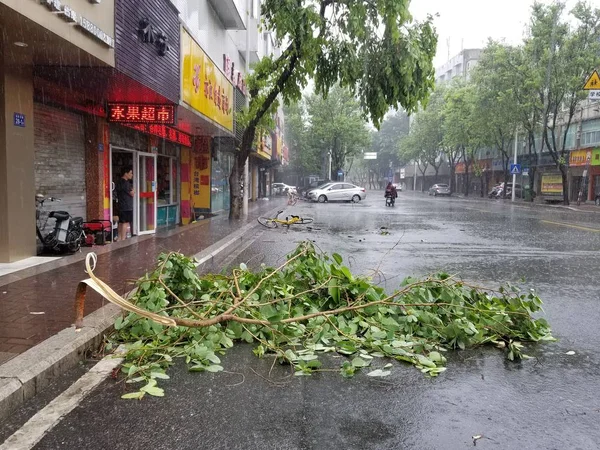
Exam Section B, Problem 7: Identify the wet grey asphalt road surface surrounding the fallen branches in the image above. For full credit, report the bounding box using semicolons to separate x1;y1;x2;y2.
8;192;600;450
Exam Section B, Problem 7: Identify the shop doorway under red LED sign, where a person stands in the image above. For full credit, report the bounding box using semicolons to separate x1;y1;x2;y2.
110;146;157;239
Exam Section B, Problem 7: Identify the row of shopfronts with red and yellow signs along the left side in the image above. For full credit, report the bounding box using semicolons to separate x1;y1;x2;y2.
0;0;284;262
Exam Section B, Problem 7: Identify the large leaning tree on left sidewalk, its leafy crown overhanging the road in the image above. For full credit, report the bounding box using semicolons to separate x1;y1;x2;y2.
229;0;437;219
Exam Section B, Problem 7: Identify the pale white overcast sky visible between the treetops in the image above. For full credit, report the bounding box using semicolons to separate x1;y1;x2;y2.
410;0;584;67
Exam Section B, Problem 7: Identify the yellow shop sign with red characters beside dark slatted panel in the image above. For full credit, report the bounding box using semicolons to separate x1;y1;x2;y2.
181;29;234;131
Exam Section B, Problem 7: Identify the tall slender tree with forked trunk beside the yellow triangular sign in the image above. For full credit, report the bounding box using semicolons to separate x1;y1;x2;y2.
524;2;600;205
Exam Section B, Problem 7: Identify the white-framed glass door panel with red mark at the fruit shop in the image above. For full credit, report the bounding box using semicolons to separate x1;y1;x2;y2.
134;152;157;234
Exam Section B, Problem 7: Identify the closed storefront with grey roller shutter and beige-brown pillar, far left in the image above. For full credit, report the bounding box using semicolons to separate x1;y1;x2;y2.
0;0;115;263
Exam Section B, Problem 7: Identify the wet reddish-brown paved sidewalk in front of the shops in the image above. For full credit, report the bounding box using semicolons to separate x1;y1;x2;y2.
0;198;285;366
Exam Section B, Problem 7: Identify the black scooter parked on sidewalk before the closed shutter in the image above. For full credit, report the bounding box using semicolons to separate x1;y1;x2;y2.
35;194;85;253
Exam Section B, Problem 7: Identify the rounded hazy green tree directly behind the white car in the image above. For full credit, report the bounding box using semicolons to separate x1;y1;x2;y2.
307;86;369;180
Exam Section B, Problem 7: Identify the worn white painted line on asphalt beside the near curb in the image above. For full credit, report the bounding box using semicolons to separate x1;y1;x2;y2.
0;350;123;450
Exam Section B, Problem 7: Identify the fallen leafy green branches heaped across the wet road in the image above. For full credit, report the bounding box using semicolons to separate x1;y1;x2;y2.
107;242;552;398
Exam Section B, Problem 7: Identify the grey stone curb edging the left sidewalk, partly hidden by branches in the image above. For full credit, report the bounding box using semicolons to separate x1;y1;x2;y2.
0;207;280;420
